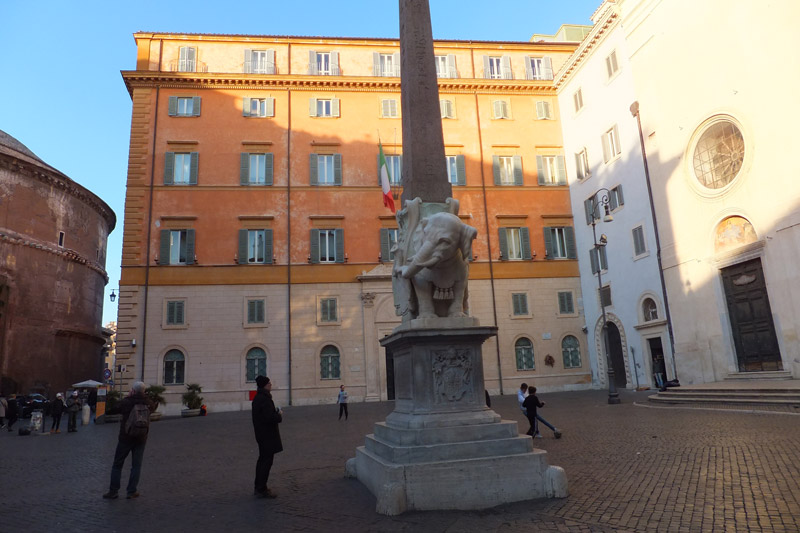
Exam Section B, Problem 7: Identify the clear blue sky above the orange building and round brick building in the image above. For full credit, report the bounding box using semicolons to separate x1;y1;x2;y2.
0;0;601;324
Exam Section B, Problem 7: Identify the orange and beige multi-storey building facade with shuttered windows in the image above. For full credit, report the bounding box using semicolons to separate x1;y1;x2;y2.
116;33;591;414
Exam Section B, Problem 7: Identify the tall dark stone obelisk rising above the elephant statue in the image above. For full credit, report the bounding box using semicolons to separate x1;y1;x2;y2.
400;0;452;204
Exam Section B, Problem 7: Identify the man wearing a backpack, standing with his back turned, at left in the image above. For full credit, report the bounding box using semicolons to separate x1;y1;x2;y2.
103;381;156;500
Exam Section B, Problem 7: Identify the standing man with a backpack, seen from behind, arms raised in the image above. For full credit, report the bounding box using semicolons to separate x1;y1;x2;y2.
103;381;156;500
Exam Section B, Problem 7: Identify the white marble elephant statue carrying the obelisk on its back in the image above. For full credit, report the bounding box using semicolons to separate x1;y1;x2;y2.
393;199;478;318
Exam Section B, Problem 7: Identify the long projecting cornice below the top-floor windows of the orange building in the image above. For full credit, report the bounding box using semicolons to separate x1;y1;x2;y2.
122;70;555;95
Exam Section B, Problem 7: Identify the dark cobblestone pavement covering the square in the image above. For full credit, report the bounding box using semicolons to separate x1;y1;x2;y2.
0;391;800;533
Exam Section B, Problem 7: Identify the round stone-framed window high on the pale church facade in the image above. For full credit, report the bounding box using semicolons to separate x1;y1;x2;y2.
692;119;744;189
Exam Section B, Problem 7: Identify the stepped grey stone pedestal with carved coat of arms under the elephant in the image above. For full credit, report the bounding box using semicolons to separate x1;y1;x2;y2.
347;318;567;515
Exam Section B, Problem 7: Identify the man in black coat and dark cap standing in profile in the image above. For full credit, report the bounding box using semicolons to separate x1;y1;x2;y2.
253;376;283;498
